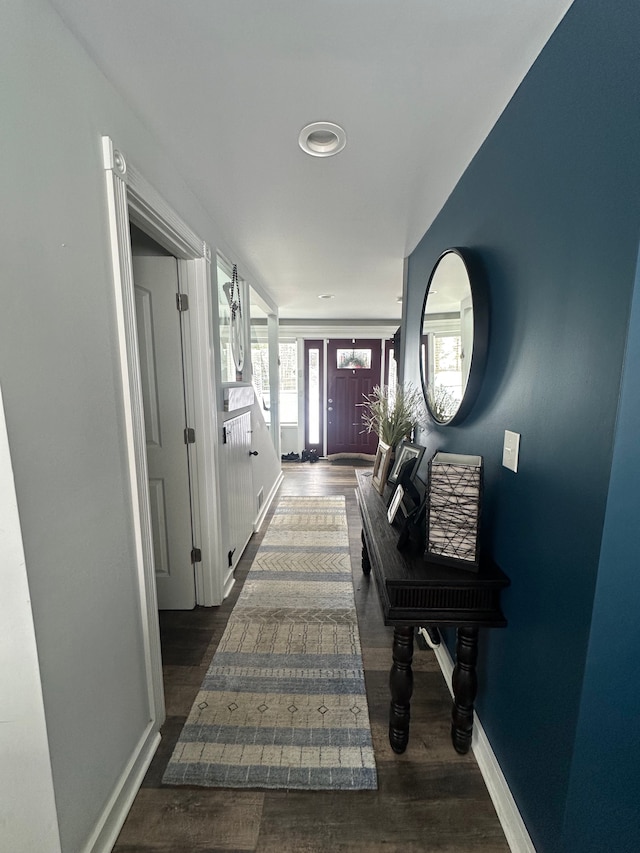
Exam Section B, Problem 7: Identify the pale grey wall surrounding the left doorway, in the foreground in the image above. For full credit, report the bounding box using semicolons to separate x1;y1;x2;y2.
0;0;278;853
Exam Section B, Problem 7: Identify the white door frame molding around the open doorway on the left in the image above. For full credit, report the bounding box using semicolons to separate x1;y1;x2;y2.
102;136;223;712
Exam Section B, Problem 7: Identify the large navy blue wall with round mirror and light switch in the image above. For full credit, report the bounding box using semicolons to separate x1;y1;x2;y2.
404;0;640;853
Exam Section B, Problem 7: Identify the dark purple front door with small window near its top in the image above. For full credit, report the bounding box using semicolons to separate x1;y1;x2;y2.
327;339;382;454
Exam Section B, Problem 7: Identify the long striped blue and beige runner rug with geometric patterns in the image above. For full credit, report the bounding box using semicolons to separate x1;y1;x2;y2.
163;496;377;790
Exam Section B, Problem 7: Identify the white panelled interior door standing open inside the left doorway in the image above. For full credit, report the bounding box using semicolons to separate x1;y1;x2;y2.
133;255;196;610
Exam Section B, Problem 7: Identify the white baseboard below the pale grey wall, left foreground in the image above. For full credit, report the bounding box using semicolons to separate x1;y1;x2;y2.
83;723;160;853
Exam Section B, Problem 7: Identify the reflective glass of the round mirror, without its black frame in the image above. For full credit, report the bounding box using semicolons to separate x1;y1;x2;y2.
420;249;474;424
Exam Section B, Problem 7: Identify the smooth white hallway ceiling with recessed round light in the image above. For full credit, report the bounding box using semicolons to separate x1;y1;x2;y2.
51;0;571;321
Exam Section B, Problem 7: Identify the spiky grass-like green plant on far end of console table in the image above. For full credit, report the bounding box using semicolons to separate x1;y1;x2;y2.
360;383;424;448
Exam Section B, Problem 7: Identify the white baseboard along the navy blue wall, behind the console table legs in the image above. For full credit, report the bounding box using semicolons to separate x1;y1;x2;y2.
433;643;536;853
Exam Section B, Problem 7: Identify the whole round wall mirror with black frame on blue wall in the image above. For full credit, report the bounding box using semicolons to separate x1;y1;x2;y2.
420;249;488;424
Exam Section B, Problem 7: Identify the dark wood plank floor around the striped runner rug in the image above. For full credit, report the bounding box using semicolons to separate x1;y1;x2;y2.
114;461;509;853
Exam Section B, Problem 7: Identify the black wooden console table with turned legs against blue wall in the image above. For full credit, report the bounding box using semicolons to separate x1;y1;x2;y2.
356;471;509;753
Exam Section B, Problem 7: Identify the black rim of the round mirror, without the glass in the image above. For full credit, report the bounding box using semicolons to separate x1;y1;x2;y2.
418;247;489;426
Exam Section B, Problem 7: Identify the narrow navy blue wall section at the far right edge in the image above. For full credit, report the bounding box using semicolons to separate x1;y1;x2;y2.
564;246;640;853
